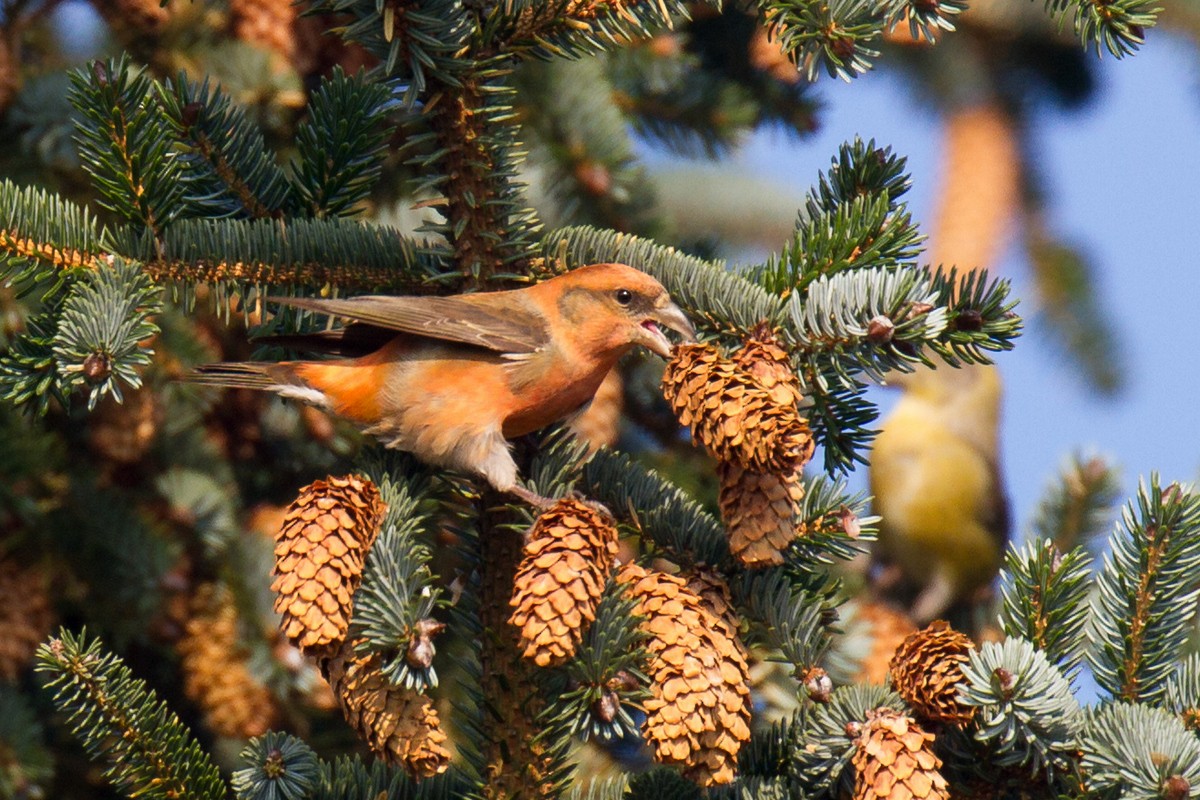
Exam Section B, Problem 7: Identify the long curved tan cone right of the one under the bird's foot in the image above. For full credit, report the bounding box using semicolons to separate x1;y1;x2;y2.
617;564;750;786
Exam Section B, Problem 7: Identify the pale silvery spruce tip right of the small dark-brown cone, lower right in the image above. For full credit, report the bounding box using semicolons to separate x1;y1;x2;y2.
961;636;1084;778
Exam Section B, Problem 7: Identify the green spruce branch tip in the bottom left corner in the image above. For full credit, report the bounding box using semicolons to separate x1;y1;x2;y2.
37;630;226;800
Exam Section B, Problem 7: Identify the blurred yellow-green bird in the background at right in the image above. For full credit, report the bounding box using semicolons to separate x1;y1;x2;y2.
870;365;1009;624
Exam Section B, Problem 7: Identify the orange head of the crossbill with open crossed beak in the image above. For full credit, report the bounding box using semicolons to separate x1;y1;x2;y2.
541;264;696;359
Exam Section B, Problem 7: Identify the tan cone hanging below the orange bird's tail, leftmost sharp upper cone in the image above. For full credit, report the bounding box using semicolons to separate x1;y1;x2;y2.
271;475;385;655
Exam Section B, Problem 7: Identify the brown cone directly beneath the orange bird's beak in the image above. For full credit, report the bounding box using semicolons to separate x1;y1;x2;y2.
662;344;814;473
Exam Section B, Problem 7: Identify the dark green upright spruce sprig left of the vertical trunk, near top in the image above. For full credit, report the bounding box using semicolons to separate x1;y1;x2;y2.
292;67;395;217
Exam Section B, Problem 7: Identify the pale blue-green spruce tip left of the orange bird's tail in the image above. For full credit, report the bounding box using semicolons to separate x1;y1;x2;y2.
54;258;162;410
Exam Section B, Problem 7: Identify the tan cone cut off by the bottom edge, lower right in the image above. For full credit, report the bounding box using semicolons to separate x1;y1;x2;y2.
853;708;950;800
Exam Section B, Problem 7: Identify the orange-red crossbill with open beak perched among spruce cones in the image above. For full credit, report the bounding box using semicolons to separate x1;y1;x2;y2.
191;264;695;505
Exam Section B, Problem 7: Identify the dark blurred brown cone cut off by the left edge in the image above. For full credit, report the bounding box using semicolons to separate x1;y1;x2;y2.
0;559;54;681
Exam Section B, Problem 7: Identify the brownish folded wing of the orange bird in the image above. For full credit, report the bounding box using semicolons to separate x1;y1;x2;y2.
270;295;550;355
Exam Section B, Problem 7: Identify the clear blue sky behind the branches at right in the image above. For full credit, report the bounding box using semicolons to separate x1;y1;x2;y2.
700;30;1200;531
